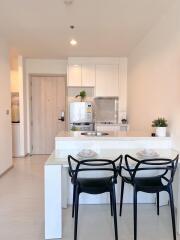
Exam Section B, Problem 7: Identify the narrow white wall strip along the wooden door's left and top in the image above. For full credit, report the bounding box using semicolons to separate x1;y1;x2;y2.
24;59;67;153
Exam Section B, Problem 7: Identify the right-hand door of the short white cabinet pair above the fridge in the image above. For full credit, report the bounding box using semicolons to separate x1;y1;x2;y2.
82;64;96;87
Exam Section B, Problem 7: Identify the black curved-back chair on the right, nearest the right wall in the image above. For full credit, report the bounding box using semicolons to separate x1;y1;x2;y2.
119;155;179;240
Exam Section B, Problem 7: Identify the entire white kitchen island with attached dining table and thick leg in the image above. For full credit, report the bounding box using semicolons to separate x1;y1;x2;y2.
45;131;179;239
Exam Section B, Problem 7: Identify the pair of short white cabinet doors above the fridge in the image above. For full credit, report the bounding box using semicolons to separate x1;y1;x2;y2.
67;64;95;87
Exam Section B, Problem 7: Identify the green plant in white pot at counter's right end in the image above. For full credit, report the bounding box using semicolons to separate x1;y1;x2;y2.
152;118;168;137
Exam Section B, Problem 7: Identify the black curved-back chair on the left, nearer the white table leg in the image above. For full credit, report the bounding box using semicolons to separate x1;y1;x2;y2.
68;155;122;240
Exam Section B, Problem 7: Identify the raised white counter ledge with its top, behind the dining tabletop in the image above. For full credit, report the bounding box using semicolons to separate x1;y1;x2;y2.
55;131;172;154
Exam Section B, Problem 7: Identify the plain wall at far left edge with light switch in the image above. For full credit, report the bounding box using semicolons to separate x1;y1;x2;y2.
0;40;12;174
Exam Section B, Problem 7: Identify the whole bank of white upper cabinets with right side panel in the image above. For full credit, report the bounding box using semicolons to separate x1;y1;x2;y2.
67;57;128;119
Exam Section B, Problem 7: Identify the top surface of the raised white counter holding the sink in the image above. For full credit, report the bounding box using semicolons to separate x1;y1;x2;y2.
56;131;170;141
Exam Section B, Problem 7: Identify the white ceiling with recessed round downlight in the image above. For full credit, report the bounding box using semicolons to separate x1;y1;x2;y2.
0;0;174;58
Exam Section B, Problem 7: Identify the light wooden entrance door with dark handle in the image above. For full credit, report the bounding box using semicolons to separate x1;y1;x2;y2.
31;76;65;154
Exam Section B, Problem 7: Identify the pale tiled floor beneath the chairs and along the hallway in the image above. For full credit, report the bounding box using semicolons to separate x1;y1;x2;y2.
0;156;180;240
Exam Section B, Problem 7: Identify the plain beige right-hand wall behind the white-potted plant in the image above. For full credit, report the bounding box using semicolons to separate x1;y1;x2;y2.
128;1;180;149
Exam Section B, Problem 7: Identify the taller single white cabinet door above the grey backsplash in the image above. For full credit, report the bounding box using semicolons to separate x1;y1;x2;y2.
95;64;119;97
